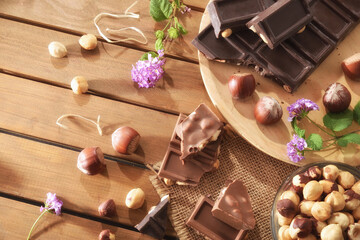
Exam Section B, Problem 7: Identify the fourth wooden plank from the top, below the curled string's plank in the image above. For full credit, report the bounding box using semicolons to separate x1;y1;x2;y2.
0;133;165;232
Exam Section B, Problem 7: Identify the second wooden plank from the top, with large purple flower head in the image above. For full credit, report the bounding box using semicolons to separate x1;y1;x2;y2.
0;19;212;113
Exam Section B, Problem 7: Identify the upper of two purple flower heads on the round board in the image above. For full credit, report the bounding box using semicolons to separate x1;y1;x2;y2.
287;98;319;122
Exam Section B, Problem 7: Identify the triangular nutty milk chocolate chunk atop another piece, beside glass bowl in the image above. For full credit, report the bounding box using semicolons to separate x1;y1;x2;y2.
211;180;255;230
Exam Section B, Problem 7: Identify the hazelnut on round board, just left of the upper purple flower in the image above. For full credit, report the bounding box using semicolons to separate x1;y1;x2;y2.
254;96;283;125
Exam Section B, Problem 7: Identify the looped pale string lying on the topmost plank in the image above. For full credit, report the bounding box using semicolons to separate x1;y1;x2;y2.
94;1;148;44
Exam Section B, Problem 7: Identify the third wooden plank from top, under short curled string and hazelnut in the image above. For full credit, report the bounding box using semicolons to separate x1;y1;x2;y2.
0;74;177;163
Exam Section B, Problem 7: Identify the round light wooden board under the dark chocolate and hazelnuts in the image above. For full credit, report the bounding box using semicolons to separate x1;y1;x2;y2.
199;8;360;166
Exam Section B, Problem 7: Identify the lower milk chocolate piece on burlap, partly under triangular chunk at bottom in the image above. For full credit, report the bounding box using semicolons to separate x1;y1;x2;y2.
186;196;247;240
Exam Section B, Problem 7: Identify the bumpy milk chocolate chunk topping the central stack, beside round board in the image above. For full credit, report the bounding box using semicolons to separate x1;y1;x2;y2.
175;104;223;160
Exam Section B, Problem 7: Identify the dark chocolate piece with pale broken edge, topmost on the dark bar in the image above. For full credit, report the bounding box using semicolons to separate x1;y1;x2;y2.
246;0;312;49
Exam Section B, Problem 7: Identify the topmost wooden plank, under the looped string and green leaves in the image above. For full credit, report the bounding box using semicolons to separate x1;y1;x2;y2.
0;0;202;61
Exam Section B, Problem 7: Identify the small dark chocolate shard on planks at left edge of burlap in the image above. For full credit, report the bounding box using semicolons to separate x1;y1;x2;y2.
135;195;169;239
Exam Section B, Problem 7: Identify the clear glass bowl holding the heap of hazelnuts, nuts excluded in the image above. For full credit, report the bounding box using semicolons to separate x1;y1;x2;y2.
270;162;360;240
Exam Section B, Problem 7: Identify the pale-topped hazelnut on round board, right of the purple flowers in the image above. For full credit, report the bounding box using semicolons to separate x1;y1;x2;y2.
323;83;351;113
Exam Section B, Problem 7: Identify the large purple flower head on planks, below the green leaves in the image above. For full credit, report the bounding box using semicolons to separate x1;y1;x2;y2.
131;50;165;88
